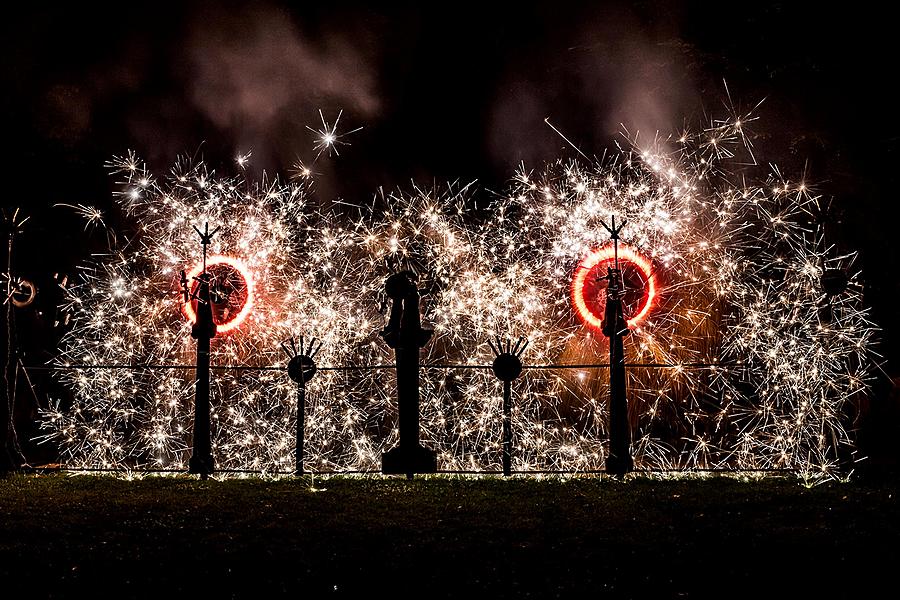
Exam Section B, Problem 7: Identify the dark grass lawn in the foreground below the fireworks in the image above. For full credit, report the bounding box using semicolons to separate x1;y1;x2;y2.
0;473;900;598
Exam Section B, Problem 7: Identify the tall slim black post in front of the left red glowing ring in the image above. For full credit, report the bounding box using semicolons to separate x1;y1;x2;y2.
181;223;219;478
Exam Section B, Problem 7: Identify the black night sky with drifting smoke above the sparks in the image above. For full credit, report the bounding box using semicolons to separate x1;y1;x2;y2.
0;1;900;376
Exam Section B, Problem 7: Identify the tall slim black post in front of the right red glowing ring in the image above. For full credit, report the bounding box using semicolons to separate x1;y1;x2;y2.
601;215;634;475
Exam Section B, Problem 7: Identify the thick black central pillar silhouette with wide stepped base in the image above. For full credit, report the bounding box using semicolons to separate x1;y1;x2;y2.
381;271;437;479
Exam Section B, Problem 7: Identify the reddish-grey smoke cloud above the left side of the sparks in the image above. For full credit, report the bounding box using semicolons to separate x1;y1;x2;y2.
186;7;381;159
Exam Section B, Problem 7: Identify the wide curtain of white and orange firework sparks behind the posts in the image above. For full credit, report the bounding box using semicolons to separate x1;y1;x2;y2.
43;111;877;475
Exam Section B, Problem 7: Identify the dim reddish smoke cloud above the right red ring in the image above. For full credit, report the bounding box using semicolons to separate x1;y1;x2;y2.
488;7;705;167
